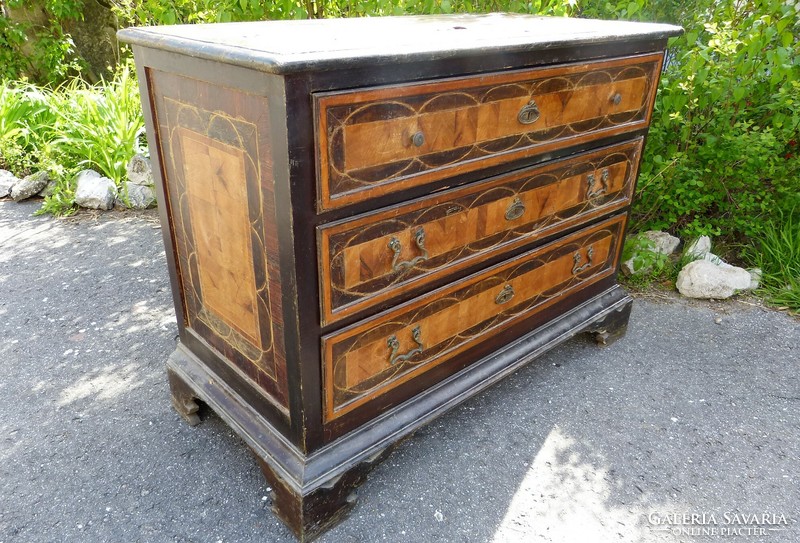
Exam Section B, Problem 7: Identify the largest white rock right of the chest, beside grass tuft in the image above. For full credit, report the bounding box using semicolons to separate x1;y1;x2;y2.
675;260;752;300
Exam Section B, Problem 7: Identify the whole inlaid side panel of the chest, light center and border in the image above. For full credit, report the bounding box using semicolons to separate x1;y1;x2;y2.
148;71;288;415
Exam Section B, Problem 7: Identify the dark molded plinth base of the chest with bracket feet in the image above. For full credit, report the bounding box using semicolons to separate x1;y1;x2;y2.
167;286;632;541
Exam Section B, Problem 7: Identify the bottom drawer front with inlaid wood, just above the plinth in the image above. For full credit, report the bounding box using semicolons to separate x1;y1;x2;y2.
322;215;626;421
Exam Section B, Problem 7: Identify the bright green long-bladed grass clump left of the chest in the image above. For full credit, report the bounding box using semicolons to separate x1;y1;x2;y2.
0;66;145;215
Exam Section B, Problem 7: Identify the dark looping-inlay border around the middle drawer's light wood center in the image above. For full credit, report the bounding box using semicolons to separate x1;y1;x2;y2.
317;137;643;325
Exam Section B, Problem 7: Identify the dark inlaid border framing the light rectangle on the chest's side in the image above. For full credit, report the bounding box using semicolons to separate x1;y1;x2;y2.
148;70;289;417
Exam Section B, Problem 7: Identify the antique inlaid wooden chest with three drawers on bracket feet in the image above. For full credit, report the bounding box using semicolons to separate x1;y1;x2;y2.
120;14;680;538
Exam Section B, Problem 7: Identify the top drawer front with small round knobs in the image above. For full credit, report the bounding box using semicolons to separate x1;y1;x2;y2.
314;53;662;209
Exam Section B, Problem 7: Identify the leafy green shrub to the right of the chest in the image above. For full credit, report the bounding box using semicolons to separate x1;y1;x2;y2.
634;0;800;239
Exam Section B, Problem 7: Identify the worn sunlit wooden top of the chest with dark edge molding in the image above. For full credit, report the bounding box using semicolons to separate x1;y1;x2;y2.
118;13;682;73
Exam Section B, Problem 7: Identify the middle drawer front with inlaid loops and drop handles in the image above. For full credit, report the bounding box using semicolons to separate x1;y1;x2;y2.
318;138;642;325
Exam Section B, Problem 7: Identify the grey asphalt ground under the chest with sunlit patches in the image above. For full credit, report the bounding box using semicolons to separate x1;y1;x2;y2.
0;201;800;543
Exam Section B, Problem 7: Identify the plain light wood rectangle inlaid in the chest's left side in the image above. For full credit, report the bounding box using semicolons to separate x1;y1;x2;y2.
179;129;262;349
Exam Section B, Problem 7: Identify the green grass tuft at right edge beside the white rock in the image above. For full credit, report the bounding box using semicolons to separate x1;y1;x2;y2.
744;207;800;313
